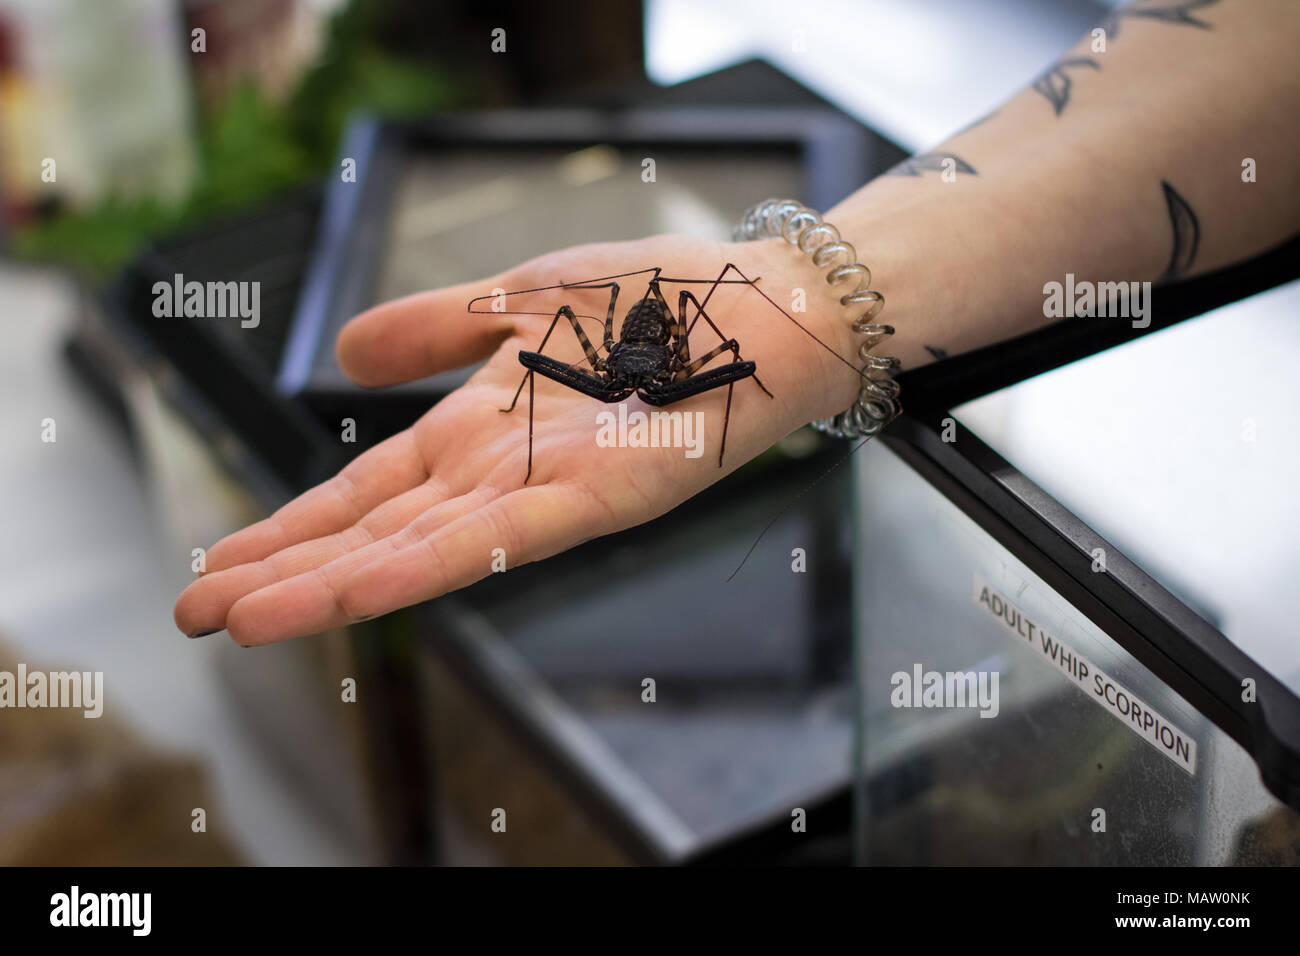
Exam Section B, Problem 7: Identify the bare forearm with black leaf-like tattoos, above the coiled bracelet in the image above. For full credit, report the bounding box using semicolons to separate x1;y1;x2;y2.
827;0;1300;379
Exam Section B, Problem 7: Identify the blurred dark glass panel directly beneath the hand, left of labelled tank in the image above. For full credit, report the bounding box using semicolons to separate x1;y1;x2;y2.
441;467;854;860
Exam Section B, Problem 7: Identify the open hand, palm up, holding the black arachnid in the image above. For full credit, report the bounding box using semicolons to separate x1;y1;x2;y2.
176;237;855;645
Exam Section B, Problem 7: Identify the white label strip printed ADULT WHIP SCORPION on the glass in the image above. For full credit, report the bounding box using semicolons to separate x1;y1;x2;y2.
974;574;1196;777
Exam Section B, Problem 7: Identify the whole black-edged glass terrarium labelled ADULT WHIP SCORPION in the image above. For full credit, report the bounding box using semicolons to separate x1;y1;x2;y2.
854;277;1300;865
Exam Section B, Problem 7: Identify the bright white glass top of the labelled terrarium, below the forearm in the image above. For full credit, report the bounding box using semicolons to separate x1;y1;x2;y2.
953;282;1300;693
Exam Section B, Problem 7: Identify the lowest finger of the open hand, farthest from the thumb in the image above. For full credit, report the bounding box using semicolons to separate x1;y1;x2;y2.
226;483;618;644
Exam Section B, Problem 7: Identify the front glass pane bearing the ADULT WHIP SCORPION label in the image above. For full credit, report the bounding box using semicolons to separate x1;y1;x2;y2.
854;442;1300;865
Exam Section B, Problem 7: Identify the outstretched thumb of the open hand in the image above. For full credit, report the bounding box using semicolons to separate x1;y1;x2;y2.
335;280;515;388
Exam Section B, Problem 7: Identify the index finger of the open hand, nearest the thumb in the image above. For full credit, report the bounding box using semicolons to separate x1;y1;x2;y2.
204;429;429;574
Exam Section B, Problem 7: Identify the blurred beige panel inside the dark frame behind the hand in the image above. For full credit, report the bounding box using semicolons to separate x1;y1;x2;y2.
377;146;805;302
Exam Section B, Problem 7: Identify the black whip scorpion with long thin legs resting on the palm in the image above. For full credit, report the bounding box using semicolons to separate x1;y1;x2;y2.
469;263;771;484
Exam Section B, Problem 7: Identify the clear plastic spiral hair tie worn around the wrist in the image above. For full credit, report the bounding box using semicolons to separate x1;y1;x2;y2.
732;199;902;438
